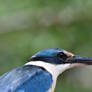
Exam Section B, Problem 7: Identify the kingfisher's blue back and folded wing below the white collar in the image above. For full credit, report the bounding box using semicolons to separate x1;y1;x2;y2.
0;65;52;92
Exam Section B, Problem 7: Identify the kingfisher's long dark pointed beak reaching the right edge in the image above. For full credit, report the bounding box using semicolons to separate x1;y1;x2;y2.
65;56;92;65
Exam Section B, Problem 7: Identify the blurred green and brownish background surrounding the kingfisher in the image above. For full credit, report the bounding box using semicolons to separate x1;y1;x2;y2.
0;0;92;92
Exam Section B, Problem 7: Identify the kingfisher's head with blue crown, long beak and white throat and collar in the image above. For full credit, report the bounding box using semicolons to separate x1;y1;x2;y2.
27;48;92;76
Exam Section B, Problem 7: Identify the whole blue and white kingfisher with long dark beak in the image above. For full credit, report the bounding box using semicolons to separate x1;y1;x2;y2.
0;48;92;92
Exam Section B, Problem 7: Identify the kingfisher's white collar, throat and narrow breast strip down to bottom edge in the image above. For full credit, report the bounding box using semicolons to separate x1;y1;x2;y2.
25;61;70;92
